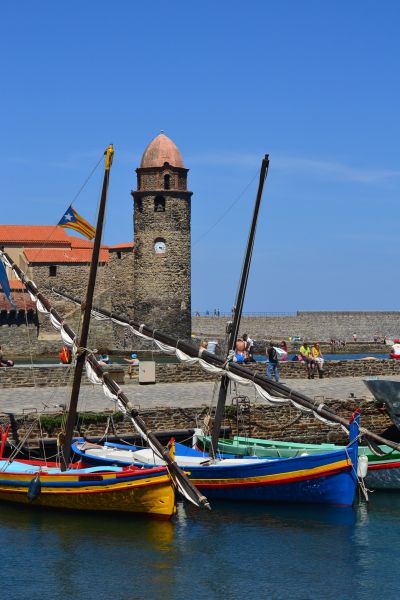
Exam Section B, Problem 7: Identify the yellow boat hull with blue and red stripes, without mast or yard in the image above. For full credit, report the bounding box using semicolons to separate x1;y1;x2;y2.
0;459;176;519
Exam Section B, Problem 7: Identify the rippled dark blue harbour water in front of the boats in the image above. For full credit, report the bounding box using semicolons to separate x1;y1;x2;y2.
0;492;400;600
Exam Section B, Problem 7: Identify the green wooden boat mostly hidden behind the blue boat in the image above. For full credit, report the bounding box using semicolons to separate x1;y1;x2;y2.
196;433;400;490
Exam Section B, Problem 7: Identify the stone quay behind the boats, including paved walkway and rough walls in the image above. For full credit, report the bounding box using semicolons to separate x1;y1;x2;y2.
0;361;400;446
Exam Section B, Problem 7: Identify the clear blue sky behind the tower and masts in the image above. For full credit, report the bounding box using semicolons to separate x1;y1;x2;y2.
0;0;400;311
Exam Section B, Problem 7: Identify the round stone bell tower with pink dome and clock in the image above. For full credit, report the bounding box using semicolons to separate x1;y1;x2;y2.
132;132;192;340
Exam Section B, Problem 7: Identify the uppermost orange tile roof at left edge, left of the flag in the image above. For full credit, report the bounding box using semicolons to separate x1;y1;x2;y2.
0;225;72;246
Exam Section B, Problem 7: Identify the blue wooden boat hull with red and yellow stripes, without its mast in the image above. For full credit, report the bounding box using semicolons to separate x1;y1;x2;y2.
72;416;358;505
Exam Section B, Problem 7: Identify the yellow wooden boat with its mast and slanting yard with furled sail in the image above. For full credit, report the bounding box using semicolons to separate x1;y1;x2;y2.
0;145;212;518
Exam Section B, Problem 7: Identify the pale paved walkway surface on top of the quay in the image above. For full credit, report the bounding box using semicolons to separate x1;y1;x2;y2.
0;376;400;414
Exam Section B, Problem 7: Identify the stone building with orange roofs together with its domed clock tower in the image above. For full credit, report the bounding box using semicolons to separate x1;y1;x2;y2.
0;133;192;353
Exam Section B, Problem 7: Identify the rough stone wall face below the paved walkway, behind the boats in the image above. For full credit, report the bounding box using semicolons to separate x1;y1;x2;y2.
8;398;392;447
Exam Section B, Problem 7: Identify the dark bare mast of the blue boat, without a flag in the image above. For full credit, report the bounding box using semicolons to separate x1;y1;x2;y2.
211;154;269;456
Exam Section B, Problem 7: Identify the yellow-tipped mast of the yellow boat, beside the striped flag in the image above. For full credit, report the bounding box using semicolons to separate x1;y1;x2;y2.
62;144;114;471
